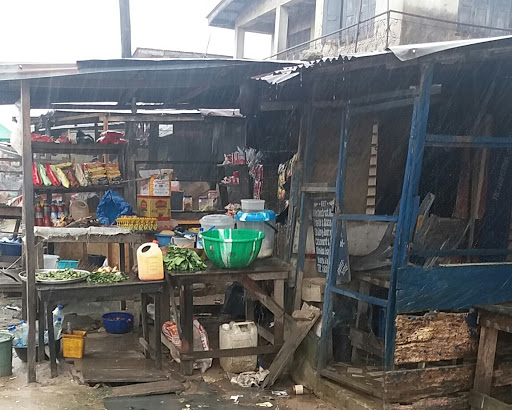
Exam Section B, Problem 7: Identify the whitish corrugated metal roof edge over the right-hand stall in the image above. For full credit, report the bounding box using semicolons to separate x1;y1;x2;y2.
252;36;512;85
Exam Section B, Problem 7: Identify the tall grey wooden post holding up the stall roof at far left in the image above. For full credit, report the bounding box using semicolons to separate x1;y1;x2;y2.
21;80;37;383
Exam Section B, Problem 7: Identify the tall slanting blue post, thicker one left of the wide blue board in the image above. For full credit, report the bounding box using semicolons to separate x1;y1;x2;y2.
384;65;434;369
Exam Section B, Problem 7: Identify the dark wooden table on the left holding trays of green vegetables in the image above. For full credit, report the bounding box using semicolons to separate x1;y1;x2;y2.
36;276;169;377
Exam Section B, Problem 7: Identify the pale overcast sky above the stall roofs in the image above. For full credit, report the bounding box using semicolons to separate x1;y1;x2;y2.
0;0;270;128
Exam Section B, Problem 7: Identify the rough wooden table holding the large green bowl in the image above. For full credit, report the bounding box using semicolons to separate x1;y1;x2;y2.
166;258;292;375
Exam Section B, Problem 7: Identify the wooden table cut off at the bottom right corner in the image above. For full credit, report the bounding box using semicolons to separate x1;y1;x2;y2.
469;303;512;410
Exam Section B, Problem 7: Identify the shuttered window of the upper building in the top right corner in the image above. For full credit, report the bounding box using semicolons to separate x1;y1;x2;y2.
458;0;512;36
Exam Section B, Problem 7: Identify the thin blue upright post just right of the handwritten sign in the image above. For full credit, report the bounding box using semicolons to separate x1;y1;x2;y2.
318;106;350;370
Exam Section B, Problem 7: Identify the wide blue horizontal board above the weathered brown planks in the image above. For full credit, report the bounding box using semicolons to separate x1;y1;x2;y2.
396;263;512;313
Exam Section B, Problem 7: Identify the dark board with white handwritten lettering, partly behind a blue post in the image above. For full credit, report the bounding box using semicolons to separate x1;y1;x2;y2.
313;198;350;282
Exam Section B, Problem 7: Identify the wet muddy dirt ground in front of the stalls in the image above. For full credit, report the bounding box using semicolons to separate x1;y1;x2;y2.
0;357;333;410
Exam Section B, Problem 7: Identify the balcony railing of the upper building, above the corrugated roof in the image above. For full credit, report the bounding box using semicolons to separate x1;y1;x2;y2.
268;10;512;60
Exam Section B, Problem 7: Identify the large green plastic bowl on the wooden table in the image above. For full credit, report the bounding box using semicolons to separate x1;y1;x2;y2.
201;229;265;268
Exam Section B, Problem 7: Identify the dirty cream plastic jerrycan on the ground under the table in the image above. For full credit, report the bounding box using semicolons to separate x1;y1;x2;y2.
219;321;258;373
